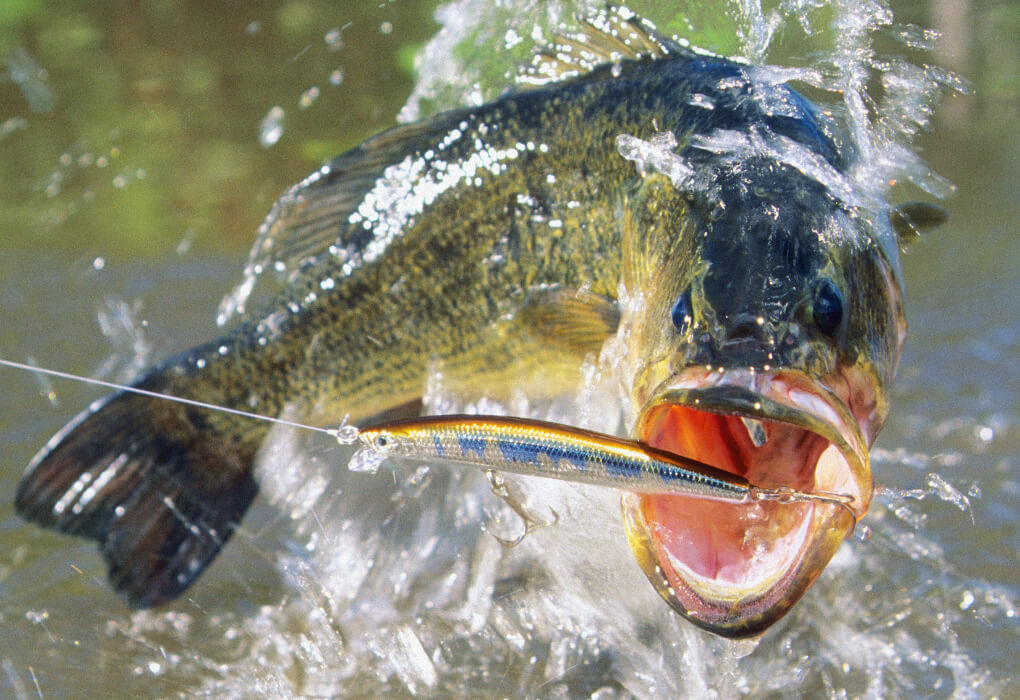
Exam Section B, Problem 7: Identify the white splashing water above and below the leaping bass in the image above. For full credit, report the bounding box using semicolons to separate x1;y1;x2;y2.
236;0;987;697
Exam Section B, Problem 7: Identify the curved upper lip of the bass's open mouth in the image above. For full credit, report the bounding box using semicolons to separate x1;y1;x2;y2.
636;367;872;519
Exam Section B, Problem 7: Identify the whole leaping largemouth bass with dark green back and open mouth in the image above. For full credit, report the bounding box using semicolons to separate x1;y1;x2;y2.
16;11;938;637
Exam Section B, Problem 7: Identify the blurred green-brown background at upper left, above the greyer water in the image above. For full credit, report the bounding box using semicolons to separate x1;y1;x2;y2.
0;0;437;257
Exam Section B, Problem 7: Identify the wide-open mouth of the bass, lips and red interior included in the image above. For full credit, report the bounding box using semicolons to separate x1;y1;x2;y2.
623;368;871;638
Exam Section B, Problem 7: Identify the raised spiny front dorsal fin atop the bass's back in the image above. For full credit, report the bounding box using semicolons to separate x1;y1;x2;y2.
517;6;683;86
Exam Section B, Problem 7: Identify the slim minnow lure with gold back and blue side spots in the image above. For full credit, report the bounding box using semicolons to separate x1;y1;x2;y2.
357;415;854;506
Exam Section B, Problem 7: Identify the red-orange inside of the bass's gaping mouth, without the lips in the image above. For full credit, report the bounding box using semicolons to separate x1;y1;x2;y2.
642;404;829;586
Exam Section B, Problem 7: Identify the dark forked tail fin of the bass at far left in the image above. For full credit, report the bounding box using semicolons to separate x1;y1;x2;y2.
16;374;258;607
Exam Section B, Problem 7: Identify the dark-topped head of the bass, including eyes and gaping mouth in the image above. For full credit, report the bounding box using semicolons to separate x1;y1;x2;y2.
623;159;906;638
